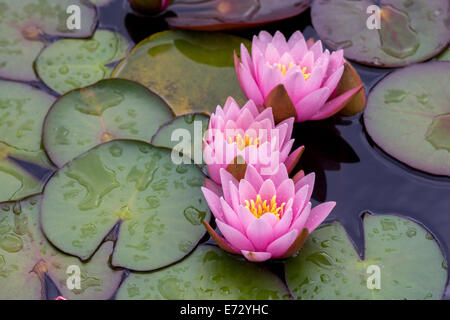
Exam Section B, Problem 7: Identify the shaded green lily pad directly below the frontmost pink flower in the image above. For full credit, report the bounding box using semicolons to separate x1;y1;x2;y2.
116;245;290;300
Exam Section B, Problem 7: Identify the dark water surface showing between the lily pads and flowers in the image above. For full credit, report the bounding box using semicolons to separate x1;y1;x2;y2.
16;0;450;299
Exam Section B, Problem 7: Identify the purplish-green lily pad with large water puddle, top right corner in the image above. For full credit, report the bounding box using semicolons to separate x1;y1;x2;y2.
311;0;450;67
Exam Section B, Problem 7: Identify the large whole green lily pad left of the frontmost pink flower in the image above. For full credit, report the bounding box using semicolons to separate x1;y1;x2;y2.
41;140;210;271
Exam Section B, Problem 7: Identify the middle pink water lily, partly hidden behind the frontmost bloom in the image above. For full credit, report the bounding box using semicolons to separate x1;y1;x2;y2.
203;97;304;184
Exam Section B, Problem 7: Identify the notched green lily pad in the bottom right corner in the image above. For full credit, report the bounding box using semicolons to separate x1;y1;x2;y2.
286;215;447;300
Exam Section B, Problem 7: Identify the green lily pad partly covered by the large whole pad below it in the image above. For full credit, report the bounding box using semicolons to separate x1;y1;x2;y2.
44;79;173;167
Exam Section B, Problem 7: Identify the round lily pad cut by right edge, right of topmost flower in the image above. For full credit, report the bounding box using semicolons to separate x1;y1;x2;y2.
364;62;450;176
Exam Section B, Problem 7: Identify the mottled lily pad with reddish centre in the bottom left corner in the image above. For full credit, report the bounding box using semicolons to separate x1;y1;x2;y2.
0;196;122;300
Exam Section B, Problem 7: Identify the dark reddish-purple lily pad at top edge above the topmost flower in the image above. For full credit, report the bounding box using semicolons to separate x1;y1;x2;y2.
166;0;309;31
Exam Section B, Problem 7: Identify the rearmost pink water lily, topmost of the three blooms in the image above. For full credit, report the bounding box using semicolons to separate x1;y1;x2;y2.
235;31;361;122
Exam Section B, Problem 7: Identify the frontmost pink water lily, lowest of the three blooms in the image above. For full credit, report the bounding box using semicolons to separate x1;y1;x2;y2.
202;164;335;262
